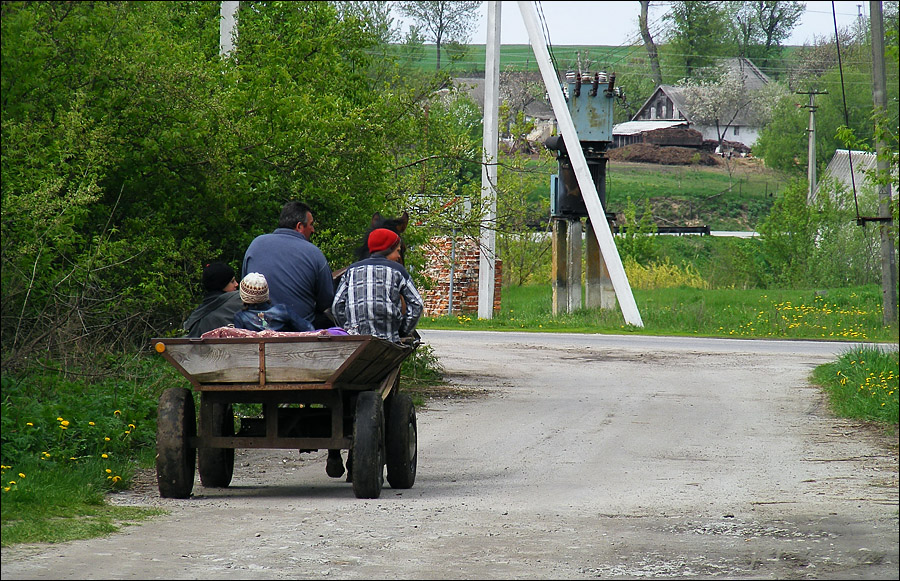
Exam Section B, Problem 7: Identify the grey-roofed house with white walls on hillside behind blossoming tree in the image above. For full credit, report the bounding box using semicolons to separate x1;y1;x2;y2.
613;57;769;148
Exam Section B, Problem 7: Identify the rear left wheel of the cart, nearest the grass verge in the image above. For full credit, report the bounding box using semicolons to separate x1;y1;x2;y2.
156;387;197;498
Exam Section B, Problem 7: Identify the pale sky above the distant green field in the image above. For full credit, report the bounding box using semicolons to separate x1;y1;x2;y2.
460;0;869;46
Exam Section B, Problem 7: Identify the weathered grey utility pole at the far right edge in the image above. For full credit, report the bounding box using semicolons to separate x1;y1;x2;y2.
869;0;897;326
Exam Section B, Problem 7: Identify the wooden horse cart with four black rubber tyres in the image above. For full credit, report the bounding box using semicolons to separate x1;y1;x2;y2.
152;333;417;498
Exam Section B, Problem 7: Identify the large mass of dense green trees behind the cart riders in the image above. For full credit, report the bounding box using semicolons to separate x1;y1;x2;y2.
0;2;480;370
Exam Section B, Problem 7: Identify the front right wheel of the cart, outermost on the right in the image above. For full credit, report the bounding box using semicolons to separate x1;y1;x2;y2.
387;393;418;488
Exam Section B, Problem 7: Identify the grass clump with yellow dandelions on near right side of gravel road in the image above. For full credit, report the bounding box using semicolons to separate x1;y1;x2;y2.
813;346;900;425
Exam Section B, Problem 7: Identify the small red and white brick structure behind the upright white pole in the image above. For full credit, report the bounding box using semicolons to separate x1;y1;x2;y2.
421;236;503;316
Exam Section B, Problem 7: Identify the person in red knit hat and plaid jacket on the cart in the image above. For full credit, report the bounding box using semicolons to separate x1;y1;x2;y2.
331;228;424;343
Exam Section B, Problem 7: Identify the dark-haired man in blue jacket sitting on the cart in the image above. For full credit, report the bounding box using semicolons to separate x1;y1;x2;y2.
241;201;334;329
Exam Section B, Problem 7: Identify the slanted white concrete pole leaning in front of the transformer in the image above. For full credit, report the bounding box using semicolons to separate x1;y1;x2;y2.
519;0;644;327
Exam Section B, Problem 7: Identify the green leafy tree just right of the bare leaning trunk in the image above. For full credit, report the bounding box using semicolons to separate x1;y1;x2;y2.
663;2;733;78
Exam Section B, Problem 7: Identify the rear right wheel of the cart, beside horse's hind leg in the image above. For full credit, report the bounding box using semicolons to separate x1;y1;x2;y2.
350;391;384;498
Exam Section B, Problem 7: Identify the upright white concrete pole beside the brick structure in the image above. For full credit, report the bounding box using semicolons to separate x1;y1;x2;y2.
478;0;500;319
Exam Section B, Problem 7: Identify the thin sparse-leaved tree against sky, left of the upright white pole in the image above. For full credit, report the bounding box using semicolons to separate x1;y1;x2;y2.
398;0;481;70
